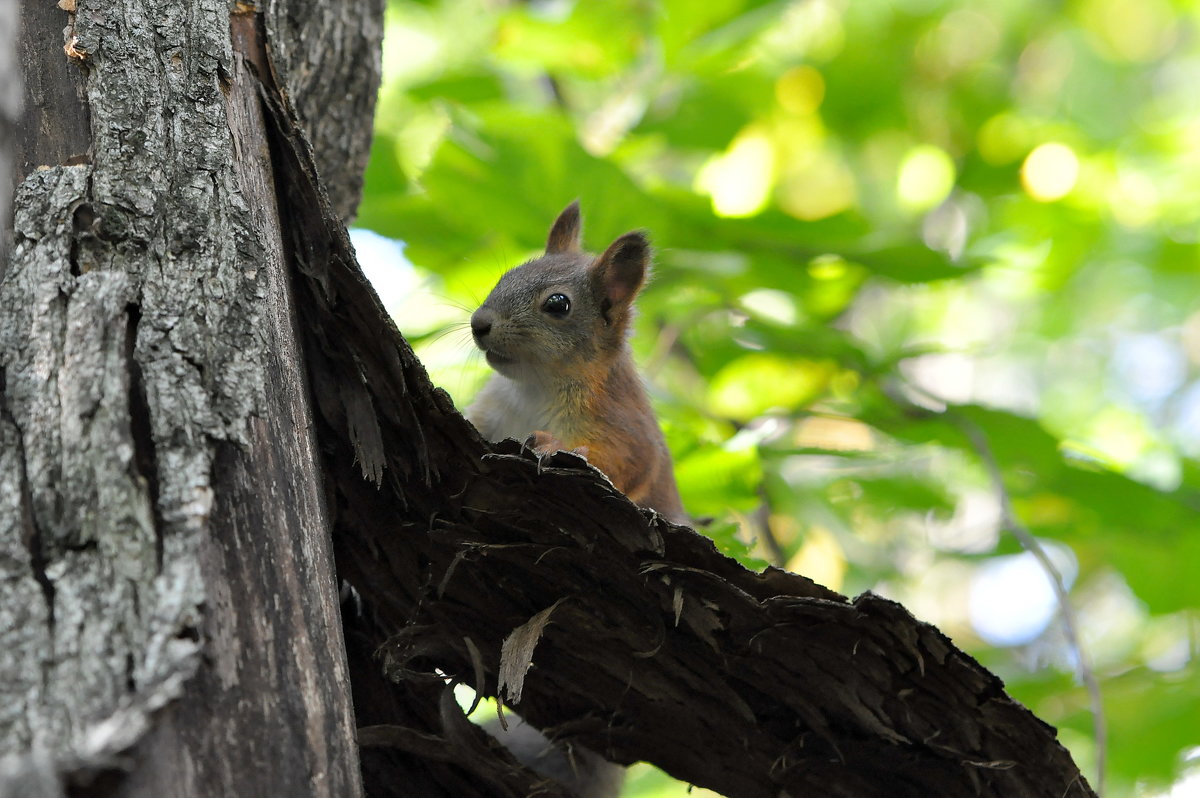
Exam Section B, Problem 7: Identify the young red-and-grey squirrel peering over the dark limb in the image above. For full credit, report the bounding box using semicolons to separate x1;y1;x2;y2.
467;200;690;524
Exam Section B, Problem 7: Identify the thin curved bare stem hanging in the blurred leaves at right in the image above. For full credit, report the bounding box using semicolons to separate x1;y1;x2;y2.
947;410;1108;798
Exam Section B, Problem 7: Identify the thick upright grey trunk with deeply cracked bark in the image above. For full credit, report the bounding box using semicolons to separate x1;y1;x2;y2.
0;0;380;796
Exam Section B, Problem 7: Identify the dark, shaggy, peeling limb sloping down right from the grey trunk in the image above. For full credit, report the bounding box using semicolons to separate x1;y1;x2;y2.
260;24;1092;798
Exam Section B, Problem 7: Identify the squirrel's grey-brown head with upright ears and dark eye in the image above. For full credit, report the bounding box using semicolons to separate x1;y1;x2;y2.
470;202;650;379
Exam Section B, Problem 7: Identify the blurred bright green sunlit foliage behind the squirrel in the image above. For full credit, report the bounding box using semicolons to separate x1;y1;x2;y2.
359;0;1200;796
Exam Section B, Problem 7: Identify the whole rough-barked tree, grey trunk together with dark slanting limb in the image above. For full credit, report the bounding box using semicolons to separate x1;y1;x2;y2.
0;0;1091;798
